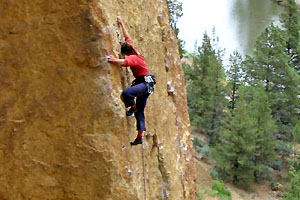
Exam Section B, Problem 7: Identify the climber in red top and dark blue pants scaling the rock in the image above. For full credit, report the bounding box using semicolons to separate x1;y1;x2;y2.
107;16;155;145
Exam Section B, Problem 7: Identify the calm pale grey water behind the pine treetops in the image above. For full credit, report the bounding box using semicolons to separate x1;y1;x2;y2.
178;0;282;59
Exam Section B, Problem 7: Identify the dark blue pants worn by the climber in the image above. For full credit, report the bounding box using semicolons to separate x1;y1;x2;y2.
122;82;149;131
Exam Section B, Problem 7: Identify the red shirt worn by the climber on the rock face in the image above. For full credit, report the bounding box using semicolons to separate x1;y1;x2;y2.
123;37;149;78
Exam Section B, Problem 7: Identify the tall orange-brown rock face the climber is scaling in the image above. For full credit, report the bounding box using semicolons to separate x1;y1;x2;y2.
0;0;195;200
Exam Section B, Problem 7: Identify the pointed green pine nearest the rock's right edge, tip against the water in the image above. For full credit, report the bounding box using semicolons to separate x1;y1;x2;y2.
185;34;226;144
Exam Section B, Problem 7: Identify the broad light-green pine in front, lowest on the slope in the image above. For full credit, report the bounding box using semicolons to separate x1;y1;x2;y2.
216;85;276;184
